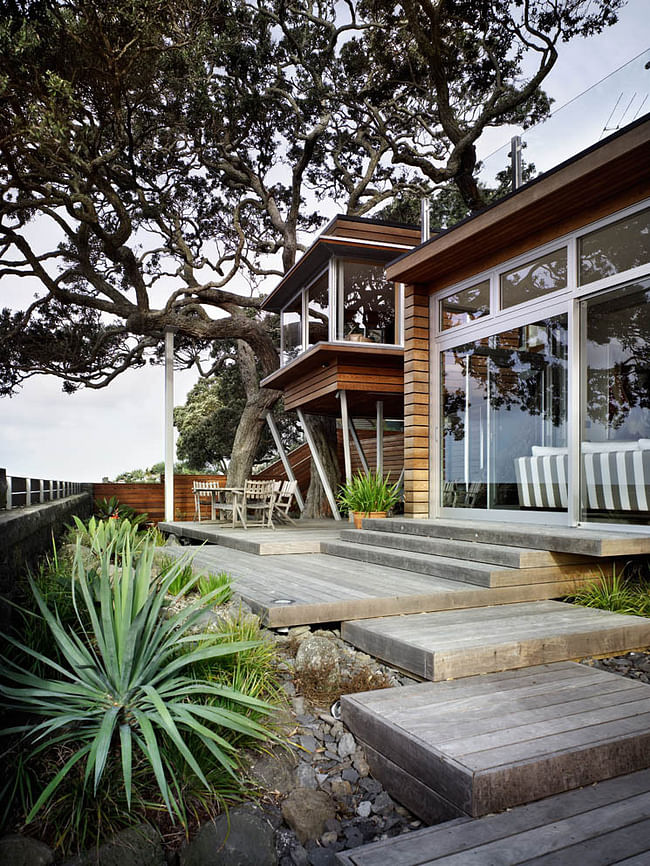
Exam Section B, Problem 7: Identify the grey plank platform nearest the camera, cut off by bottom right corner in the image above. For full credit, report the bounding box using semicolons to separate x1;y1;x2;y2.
338;770;650;866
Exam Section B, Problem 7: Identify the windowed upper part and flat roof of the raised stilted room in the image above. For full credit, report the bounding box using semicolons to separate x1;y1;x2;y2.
263;216;420;366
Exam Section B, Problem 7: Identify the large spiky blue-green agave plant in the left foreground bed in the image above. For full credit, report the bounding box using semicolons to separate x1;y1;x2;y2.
0;539;273;823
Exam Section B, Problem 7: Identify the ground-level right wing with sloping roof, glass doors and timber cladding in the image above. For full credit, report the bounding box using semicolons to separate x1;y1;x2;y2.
386;115;650;527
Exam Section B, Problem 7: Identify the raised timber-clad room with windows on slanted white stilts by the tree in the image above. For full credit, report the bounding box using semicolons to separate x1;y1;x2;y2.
262;216;420;517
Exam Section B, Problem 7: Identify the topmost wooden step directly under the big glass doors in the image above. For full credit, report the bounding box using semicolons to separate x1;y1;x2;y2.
363;517;650;557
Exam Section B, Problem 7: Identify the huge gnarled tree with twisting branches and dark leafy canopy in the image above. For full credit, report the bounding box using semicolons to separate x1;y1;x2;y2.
0;0;622;500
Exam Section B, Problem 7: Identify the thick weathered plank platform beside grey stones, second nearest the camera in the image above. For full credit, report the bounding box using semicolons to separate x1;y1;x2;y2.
341;662;650;820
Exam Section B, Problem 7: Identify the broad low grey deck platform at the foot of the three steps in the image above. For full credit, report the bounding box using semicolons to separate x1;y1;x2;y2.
162;544;579;628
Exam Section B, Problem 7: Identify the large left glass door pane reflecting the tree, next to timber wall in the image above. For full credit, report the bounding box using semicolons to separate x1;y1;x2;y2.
442;314;567;510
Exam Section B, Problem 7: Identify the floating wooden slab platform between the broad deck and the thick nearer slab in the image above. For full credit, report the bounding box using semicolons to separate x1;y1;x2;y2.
342;601;650;681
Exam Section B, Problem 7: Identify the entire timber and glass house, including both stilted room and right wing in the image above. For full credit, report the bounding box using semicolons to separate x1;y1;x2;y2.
264;116;650;528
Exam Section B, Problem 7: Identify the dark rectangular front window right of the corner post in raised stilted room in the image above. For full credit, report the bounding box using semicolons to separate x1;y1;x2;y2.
339;261;396;343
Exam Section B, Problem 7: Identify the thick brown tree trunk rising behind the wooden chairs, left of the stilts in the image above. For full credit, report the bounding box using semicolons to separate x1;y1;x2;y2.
227;340;281;487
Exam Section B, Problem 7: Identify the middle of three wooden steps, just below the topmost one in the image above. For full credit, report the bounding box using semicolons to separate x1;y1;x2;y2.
341;529;587;568
